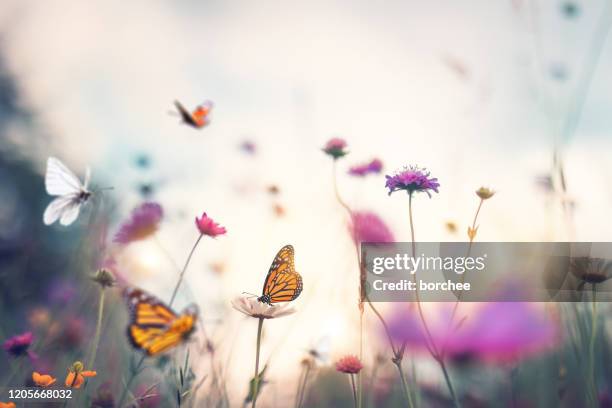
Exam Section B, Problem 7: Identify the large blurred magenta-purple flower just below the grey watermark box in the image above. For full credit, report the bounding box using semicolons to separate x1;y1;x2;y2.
389;302;559;361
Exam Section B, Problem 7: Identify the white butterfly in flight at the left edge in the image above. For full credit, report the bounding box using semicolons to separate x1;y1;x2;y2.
43;157;92;225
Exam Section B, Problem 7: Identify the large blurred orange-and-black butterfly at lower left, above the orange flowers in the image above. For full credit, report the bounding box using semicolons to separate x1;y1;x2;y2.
125;288;198;356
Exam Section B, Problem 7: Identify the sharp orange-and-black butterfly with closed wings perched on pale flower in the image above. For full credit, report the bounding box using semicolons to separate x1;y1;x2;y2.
257;245;302;305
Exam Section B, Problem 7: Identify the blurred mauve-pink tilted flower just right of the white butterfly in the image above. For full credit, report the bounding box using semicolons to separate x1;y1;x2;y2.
113;203;164;245
